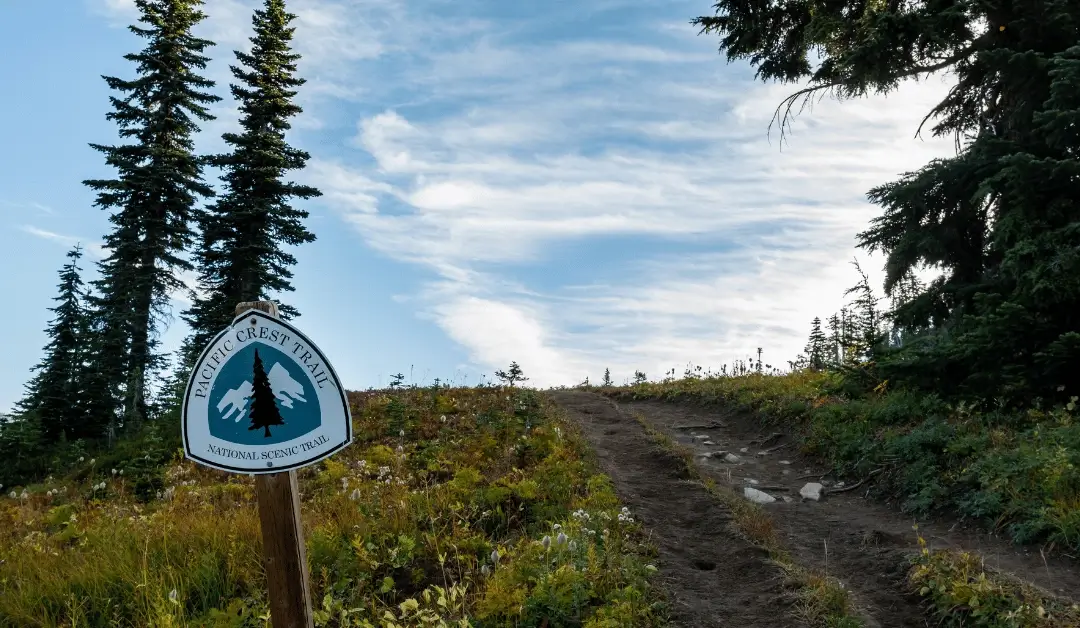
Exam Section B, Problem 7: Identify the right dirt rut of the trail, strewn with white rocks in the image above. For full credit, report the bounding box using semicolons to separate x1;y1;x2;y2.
618;402;1080;627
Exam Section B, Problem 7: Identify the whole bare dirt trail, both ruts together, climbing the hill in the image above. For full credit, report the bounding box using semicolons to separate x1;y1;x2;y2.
552;391;1080;628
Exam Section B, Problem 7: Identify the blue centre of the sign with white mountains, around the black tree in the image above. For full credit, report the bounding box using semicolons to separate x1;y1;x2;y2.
208;340;322;445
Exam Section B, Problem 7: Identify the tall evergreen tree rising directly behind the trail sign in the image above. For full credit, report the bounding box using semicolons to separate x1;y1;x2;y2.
184;0;321;368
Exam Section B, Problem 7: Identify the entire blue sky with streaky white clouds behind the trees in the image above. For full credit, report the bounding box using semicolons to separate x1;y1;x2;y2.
0;0;954;411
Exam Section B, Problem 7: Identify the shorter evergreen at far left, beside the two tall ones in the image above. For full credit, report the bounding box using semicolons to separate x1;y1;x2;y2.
19;245;86;442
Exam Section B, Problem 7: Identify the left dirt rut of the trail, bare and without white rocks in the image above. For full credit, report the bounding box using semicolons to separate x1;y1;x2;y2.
551;391;800;628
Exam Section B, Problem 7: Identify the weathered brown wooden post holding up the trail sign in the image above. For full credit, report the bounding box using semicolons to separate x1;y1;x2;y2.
237;300;314;628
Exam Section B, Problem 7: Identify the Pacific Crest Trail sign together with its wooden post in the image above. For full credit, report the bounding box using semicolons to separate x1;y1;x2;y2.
181;302;352;628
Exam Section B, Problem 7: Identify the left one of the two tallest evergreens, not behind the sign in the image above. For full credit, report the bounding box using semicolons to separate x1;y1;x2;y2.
84;0;220;429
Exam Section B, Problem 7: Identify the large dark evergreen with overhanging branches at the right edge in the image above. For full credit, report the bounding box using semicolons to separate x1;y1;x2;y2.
696;0;1080;403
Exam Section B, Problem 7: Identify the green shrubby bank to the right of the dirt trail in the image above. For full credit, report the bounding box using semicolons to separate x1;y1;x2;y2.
600;371;1080;551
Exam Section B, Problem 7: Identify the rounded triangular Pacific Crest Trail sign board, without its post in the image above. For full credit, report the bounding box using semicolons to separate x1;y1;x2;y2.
183;304;352;473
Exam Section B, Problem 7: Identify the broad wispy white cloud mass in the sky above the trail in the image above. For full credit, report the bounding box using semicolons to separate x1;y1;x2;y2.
314;22;951;385
